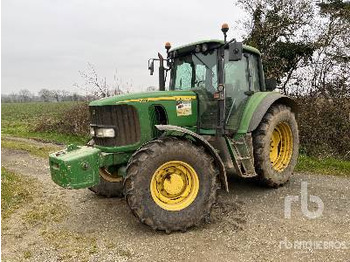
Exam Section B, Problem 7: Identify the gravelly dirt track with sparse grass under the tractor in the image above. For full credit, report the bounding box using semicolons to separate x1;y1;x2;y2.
1;145;350;261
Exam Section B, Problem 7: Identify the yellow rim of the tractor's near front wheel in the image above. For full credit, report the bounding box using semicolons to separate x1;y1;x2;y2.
150;161;199;211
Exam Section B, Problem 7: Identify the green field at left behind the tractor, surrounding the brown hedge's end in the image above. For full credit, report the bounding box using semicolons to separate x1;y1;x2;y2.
1;102;88;144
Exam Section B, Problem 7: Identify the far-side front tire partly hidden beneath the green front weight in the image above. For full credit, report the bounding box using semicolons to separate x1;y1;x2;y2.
89;171;123;198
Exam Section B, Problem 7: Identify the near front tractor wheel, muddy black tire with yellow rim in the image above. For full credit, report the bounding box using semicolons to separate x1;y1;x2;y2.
124;137;219;233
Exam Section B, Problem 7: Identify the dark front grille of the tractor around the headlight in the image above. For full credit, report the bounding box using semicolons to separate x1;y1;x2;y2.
90;105;140;146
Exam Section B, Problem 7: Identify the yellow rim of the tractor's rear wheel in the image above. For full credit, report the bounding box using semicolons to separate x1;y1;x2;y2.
270;122;293;172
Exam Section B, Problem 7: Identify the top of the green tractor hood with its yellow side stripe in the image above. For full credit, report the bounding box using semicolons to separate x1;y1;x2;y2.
90;91;196;106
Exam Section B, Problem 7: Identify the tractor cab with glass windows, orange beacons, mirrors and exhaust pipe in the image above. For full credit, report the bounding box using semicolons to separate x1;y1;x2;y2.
149;24;275;134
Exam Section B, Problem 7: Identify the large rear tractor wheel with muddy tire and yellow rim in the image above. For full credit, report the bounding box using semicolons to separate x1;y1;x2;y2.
253;104;299;187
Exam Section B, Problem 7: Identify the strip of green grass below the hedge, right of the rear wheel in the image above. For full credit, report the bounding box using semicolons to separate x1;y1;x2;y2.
296;155;350;177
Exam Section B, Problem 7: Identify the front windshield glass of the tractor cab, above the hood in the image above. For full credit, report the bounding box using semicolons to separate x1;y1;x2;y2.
170;50;218;93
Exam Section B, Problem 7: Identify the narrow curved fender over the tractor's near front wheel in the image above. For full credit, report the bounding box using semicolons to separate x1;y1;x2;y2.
156;125;229;192
